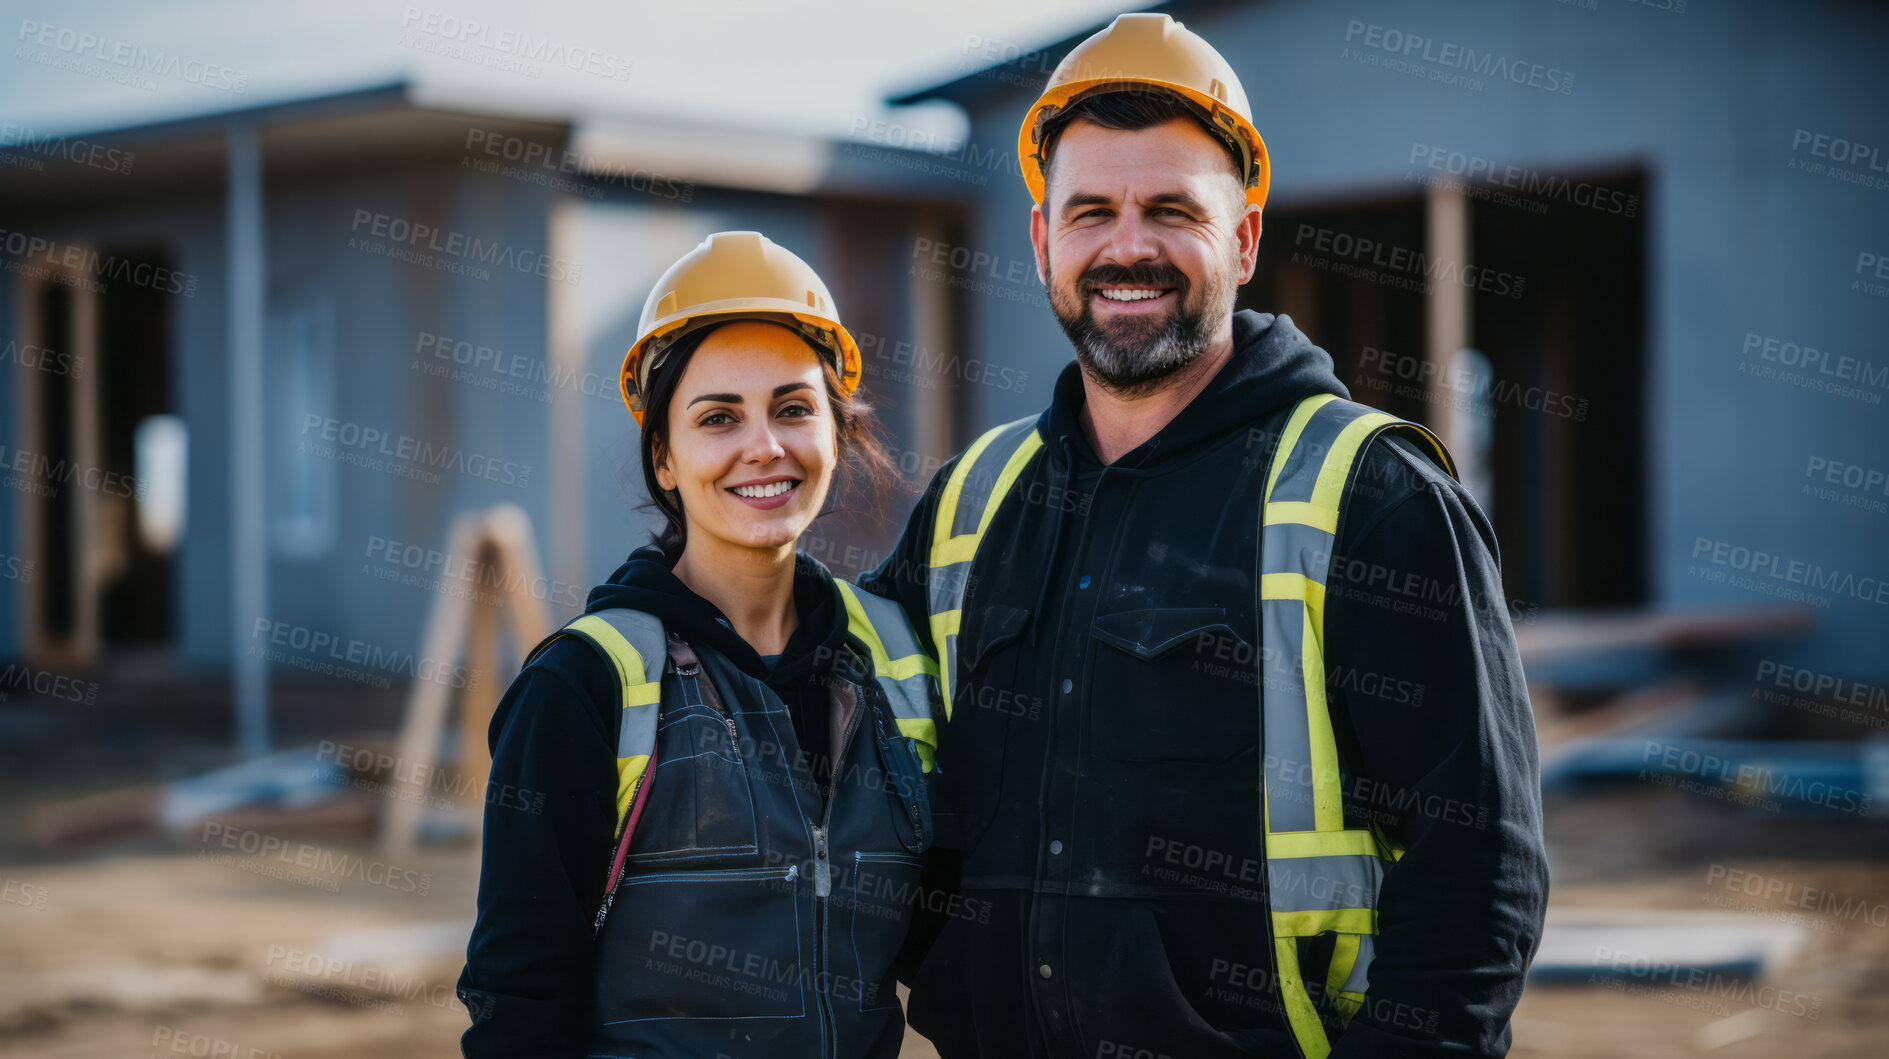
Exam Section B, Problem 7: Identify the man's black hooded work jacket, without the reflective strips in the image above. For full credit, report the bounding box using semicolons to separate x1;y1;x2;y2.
861;311;1547;1059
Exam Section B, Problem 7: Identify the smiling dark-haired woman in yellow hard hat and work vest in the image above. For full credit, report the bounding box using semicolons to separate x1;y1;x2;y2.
459;232;937;1059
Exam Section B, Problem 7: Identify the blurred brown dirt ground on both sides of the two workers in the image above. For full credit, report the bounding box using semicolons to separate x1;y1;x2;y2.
0;789;1889;1059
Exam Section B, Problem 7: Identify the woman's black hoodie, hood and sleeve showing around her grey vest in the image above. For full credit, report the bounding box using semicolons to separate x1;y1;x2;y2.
459;546;846;1059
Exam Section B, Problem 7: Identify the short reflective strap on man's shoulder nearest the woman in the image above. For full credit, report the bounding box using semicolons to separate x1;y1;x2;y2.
926;415;1043;709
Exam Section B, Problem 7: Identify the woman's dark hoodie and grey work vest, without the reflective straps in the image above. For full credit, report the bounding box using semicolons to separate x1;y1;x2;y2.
459;547;929;1059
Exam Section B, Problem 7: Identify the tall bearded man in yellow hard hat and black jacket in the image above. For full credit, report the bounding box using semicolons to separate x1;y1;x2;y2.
865;15;1547;1059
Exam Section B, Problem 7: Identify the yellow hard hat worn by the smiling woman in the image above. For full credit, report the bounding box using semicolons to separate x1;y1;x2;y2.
618;232;859;427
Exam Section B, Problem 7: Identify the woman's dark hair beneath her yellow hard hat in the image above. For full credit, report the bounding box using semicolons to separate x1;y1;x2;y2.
642;317;899;563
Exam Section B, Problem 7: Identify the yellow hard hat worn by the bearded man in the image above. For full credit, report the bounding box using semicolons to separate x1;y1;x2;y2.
1016;13;1273;208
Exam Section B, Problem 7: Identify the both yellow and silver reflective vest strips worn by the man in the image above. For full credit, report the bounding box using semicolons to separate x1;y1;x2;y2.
927;395;1456;1059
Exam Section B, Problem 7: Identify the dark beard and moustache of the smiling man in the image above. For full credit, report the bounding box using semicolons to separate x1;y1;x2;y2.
1045;264;1232;396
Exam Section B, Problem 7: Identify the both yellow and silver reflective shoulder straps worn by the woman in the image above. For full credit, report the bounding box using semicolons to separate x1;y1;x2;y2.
525;578;939;898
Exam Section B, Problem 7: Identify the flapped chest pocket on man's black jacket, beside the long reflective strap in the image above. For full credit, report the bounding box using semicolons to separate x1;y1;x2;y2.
1090;606;1260;765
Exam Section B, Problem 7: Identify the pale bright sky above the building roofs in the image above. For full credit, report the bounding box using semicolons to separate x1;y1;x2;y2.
0;0;1118;144
